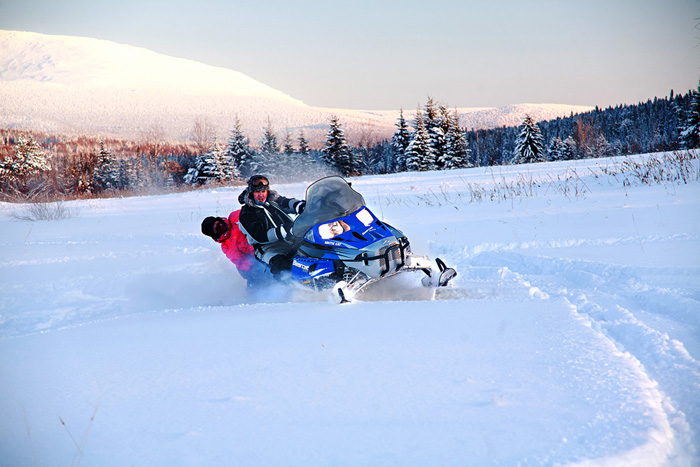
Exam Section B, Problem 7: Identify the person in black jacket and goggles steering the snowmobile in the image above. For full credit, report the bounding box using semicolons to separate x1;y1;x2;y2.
238;175;306;275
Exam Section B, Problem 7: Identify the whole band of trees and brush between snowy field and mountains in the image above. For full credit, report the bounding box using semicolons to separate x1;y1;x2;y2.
0;85;700;200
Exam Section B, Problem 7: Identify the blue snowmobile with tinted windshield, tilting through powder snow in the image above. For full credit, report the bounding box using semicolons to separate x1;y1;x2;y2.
292;176;457;303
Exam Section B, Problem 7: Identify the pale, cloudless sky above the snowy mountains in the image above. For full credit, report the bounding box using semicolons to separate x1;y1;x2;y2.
0;0;700;110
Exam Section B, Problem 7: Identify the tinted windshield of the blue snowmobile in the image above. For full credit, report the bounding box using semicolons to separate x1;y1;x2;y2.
292;177;365;237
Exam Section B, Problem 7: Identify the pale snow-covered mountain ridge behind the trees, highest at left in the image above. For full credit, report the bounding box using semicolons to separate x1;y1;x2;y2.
0;31;590;143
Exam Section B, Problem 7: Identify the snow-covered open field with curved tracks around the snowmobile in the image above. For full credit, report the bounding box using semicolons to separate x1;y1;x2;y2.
0;153;700;466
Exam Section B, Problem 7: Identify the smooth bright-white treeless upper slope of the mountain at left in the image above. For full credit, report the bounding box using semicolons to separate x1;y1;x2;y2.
0;31;303;105
